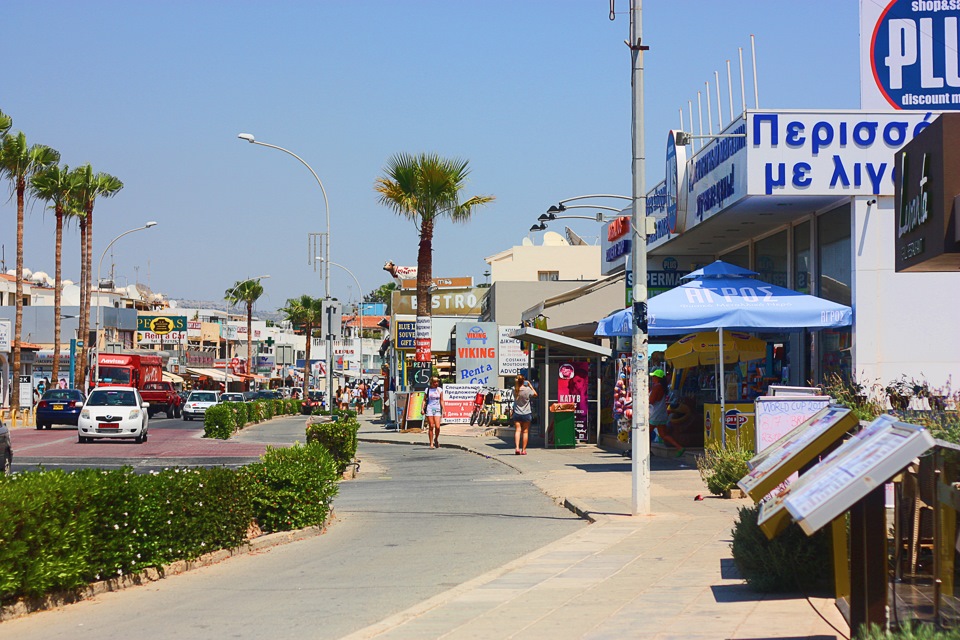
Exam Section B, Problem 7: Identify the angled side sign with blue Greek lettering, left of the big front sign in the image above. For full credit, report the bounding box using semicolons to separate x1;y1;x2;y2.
688;120;747;226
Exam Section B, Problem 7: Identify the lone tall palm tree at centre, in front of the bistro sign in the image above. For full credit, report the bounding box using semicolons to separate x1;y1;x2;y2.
374;153;494;372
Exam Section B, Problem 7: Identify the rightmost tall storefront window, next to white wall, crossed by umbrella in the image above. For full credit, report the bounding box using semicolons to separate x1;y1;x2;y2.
817;205;853;379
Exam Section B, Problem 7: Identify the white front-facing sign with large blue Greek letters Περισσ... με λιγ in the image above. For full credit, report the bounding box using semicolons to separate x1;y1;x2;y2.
747;111;936;196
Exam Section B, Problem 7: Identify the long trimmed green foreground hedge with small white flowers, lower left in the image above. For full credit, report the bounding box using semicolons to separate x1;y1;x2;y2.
0;445;339;603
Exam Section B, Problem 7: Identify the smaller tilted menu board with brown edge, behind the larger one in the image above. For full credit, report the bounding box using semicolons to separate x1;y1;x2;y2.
737;407;858;502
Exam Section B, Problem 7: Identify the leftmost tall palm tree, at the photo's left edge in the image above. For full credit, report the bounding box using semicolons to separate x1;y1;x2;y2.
0;132;60;408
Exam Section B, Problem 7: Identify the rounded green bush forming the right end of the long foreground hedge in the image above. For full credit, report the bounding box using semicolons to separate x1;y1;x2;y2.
243;443;340;531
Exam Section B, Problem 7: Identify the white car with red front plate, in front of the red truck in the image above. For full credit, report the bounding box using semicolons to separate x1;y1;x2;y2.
77;387;150;444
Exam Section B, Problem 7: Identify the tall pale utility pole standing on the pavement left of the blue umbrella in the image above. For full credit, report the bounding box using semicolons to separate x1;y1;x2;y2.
630;0;652;515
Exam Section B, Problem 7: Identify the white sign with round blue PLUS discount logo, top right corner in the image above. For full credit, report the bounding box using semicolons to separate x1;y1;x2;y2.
860;0;960;111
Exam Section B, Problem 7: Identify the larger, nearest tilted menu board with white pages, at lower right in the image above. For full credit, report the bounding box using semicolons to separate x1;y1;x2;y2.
758;415;934;538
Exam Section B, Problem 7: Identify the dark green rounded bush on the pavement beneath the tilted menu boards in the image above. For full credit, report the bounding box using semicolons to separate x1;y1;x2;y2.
730;506;833;593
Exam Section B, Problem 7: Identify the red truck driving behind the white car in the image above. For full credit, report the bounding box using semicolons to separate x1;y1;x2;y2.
94;353;183;418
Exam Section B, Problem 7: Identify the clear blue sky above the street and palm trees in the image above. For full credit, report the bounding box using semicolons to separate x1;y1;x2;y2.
0;0;859;309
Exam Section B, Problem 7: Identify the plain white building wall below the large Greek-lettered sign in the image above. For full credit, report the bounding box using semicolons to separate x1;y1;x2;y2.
850;196;960;391
